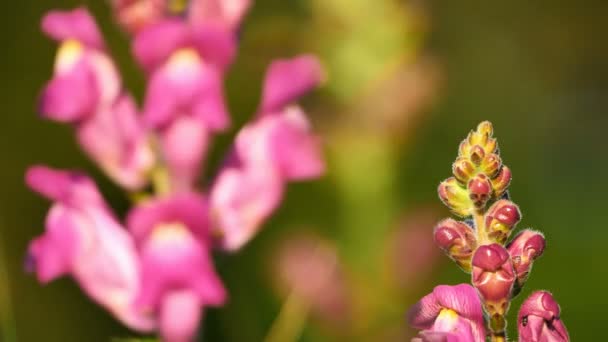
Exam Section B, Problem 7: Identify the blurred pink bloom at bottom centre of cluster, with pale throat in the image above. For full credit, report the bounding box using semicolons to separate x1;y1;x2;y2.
127;193;226;342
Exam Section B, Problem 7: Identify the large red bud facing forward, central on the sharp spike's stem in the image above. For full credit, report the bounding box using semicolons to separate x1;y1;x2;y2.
472;243;515;316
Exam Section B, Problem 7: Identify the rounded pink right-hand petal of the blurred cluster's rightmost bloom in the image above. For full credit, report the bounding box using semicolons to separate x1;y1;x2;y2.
270;108;325;180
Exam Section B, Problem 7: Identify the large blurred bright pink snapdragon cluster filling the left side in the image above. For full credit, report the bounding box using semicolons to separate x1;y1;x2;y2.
26;0;324;341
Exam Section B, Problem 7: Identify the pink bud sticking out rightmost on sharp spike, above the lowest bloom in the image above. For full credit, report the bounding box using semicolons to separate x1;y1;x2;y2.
507;229;545;289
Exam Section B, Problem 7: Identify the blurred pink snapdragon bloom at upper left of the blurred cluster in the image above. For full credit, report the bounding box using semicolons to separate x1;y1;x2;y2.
40;8;154;189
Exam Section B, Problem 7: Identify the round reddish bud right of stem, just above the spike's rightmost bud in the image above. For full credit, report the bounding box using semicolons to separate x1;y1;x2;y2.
485;200;521;245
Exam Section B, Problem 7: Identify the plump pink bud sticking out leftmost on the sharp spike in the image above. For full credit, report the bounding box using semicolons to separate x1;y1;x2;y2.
434;219;477;272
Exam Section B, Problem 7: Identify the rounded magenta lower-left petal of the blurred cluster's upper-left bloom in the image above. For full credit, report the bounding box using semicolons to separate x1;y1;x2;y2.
39;60;99;122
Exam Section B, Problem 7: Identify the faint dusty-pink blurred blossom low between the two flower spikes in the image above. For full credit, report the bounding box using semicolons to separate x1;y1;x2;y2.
273;235;352;329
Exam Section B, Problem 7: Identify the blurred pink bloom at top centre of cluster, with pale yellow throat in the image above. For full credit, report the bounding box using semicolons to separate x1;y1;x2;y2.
133;20;235;191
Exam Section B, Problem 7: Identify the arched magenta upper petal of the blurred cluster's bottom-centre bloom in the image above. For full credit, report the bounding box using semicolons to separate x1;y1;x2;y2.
127;193;209;244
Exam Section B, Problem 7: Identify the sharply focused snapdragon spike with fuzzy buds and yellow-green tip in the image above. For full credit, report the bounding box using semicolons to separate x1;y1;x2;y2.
409;121;569;342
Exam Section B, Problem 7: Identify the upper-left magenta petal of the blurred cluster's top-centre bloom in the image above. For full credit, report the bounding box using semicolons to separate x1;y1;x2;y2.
132;19;190;71
